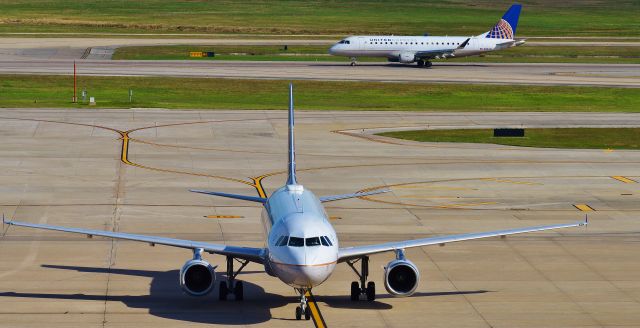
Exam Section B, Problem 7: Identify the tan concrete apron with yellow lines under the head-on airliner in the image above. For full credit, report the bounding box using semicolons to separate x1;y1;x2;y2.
0;108;640;327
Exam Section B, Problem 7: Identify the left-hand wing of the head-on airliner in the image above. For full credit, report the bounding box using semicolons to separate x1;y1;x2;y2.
3;220;265;263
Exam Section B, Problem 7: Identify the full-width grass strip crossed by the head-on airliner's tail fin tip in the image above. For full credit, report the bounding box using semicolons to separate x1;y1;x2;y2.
0;75;640;112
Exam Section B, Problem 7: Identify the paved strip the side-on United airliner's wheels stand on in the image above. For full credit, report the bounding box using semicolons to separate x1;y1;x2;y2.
0;60;640;88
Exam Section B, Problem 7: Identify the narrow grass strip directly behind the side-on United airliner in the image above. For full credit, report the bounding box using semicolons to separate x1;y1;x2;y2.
113;45;640;64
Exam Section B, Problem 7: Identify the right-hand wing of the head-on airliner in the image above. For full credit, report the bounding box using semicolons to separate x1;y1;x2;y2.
338;220;588;262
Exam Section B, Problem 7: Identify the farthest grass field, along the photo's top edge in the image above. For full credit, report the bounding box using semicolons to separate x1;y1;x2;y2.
0;0;640;36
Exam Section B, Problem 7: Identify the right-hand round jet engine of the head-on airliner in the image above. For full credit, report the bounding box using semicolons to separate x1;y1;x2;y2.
384;259;420;297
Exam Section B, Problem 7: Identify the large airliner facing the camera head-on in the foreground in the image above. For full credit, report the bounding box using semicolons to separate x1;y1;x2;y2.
3;85;587;320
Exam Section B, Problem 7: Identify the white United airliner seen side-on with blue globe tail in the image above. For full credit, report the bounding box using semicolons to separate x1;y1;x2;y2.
329;4;525;67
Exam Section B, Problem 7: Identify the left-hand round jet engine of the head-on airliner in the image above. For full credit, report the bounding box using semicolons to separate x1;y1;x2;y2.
180;259;216;296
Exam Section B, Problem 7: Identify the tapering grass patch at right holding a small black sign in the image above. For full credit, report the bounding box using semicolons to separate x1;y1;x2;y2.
380;128;640;149
